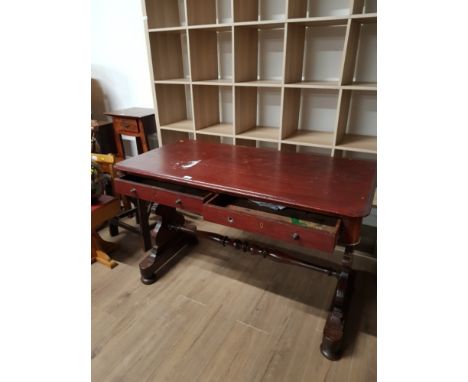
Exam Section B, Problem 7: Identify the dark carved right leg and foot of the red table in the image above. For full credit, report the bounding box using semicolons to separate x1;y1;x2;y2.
320;246;353;360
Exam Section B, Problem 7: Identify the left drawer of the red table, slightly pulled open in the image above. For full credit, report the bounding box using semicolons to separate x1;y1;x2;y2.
114;175;212;214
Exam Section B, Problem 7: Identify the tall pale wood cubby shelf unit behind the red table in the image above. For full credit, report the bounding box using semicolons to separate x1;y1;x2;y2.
146;0;377;160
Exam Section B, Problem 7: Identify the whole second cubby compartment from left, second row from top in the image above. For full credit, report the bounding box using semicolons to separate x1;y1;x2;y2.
189;27;233;82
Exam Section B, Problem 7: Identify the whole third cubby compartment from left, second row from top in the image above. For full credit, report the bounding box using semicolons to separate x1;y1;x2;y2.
234;24;284;84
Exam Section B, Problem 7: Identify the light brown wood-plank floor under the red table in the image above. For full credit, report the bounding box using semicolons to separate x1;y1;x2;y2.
91;218;377;382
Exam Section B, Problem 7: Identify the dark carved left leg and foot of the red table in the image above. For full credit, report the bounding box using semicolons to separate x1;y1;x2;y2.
140;204;197;285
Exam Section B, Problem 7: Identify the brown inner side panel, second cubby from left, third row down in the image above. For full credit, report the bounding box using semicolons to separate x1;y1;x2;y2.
193;85;220;130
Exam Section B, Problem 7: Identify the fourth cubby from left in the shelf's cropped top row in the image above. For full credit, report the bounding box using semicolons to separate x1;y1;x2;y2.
288;0;352;19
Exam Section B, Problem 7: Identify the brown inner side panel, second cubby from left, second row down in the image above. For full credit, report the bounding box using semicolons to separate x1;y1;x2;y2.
189;29;218;81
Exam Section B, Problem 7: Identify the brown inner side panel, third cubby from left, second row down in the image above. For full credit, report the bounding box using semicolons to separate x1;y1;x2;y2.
234;27;258;82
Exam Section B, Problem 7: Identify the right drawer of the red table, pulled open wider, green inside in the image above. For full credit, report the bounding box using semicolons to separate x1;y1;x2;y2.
203;194;340;253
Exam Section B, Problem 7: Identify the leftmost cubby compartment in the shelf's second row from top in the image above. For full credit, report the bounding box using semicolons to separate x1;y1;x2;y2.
149;31;190;83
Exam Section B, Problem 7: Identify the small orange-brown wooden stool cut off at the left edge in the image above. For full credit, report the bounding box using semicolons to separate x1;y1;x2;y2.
91;195;120;269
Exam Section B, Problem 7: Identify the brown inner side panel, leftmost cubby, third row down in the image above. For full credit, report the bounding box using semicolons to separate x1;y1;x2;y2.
156;84;187;125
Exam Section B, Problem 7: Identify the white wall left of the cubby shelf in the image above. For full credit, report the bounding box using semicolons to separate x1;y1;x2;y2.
91;0;154;155
